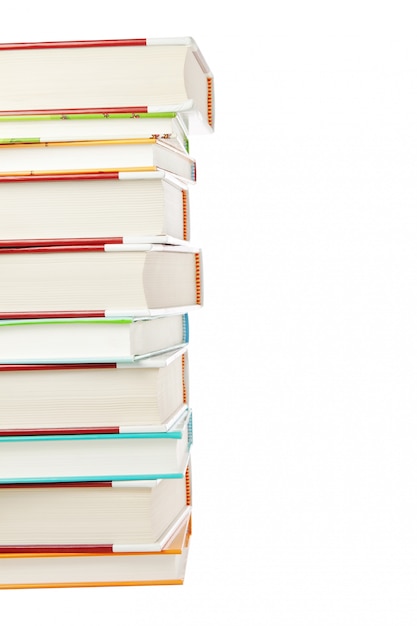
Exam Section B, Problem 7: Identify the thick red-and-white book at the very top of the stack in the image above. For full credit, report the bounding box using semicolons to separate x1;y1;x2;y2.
0;37;214;133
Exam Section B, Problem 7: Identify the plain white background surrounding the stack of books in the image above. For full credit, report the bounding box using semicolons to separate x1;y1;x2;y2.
0;0;417;626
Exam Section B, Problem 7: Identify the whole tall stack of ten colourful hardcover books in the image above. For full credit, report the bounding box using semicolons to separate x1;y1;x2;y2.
0;38;214;589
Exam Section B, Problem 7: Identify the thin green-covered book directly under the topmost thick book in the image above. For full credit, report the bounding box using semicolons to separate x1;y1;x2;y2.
0;112;189;152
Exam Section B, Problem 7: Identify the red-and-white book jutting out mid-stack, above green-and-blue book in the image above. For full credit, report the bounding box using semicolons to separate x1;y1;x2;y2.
0;244;202;319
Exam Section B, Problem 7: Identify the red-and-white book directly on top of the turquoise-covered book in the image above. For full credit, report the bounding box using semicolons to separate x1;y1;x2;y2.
0;346;189;436
